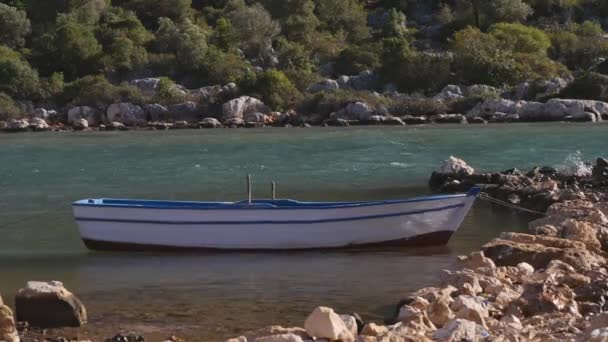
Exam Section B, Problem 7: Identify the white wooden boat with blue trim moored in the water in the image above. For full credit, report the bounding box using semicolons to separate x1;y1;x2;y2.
73;188;480;251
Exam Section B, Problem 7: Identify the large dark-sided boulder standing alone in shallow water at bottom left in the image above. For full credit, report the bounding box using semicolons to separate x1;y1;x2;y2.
15;281;87;328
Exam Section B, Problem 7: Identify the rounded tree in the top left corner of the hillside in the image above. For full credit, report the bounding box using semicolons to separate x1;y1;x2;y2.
0;3;31;48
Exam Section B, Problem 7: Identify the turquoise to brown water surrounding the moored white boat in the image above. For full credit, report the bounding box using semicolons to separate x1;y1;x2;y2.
0;124;608;341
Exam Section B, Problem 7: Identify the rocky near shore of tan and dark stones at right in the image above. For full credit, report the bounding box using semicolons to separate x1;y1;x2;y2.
226;157;608;342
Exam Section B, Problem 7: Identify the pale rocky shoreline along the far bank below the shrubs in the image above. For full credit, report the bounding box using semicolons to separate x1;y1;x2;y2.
0;75;608;132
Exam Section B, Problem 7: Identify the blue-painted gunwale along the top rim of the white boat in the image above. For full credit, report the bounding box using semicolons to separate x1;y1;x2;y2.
72;187;481;210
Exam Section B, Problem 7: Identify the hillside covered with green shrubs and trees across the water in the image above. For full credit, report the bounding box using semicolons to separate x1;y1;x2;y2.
0;0;608;127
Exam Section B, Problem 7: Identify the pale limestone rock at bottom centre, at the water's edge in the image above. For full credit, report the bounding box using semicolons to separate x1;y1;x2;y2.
304;306;355;342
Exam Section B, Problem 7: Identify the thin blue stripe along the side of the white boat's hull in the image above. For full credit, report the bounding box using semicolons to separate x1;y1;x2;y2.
76;203;465;225
